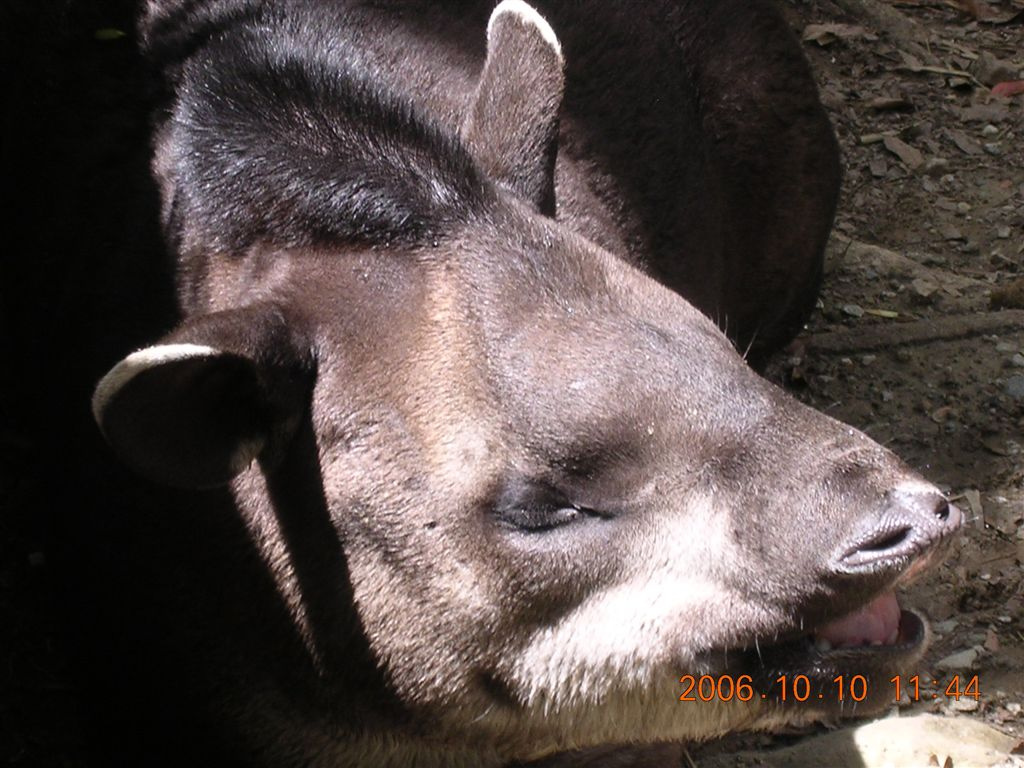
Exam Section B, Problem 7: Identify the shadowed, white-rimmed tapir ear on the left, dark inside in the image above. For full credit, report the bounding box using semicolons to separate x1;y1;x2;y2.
92;305;313;488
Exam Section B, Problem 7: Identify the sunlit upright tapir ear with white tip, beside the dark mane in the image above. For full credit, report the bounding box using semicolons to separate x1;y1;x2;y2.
462;0;565;216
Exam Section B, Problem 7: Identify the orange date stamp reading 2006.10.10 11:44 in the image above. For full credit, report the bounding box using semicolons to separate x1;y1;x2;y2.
679;675;981;702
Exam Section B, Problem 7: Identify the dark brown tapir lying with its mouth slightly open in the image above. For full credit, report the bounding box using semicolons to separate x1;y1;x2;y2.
86;0;962;768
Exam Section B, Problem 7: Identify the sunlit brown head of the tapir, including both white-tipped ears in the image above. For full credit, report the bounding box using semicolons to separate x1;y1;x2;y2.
94;2;961;758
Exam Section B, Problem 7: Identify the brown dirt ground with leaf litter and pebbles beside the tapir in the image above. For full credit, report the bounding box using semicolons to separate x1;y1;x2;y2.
712;0;1024;765
